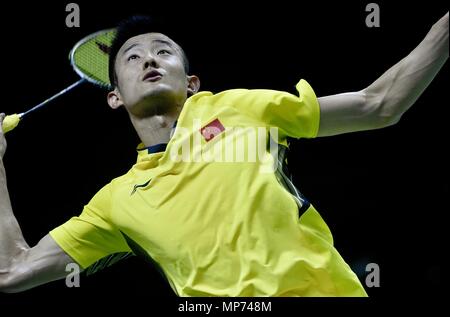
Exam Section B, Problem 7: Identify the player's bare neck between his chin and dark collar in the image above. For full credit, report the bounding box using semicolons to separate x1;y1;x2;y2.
130;108;181;147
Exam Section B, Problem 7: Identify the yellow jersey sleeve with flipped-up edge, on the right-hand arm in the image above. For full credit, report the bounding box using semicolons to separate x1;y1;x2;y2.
222;79;320;139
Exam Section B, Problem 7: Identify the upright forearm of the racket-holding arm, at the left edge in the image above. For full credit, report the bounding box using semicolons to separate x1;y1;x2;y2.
0;158;29;270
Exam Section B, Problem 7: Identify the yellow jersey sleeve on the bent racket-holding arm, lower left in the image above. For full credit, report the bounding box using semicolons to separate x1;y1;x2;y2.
50;184;131;269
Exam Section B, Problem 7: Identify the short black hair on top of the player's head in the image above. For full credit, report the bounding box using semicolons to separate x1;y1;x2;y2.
108;15;189;88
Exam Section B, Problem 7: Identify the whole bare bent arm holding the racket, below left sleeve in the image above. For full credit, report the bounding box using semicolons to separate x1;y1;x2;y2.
0;114;74;292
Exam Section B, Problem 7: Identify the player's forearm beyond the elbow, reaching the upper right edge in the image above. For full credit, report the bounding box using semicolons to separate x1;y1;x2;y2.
365;13;449;120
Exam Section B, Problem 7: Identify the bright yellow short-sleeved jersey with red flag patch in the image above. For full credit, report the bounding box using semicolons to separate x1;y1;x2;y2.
50;80;366;296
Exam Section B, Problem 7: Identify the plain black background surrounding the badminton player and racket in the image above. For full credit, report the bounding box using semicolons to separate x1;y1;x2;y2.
0;1;450;304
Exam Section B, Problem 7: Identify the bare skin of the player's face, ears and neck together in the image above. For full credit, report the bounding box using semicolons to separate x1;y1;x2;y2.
108;33;200;146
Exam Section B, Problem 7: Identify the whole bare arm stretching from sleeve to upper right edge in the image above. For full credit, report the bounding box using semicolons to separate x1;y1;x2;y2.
318;12;449;136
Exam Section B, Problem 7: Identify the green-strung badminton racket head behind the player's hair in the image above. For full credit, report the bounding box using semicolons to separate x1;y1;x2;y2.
69;28;116;89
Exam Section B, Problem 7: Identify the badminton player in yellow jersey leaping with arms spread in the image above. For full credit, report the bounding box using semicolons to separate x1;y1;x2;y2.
0;13;448;296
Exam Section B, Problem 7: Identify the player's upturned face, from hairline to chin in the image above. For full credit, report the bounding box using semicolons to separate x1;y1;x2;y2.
115;33;189;117
